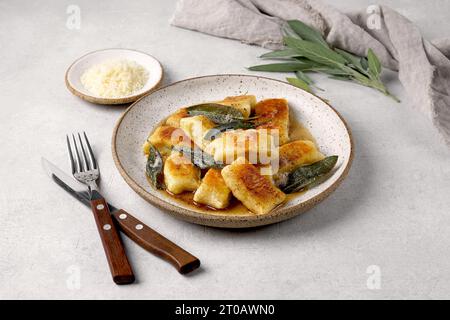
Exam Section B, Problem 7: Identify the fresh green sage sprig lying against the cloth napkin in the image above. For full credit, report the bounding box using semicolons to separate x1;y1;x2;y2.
249;20;400;102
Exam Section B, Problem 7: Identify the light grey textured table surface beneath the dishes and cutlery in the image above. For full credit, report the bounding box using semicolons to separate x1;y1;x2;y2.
0;0;450;299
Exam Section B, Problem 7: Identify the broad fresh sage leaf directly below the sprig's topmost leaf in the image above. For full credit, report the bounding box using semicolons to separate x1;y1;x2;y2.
283;37;347;67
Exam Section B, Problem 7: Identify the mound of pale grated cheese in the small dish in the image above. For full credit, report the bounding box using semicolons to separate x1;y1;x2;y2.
81;59;148;98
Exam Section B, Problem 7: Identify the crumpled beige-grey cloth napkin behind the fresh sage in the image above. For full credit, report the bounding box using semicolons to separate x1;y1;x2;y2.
171;0;450;145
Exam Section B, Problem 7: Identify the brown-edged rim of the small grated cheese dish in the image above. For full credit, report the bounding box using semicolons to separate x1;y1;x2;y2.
64;48;164;105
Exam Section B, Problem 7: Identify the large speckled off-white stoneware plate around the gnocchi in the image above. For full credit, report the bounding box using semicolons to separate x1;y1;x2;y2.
112;75;353;228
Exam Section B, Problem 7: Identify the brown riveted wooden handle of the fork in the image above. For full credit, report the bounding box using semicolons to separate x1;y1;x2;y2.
91;198;134;284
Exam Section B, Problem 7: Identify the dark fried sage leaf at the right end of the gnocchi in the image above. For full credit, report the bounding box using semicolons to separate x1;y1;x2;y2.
281;156;338;193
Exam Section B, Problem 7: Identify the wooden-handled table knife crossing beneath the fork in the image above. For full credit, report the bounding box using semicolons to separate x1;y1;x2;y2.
42;158;200;274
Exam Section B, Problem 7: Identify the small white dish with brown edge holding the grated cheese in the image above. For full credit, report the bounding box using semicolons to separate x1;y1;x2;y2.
66;48;163;104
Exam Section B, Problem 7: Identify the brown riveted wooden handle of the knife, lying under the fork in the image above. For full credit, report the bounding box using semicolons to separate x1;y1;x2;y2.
112;210;200;274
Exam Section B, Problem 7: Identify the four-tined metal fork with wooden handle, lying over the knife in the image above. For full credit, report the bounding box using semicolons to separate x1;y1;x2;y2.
66;132;134;284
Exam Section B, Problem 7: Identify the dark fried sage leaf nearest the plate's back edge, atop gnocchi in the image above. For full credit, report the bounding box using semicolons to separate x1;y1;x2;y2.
187;103;244;124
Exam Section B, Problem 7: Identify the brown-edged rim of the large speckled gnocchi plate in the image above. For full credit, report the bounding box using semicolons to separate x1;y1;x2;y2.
111;74;355;228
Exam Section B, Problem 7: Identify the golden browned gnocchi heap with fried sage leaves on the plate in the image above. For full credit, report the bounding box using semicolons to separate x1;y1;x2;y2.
143;95;337;214
